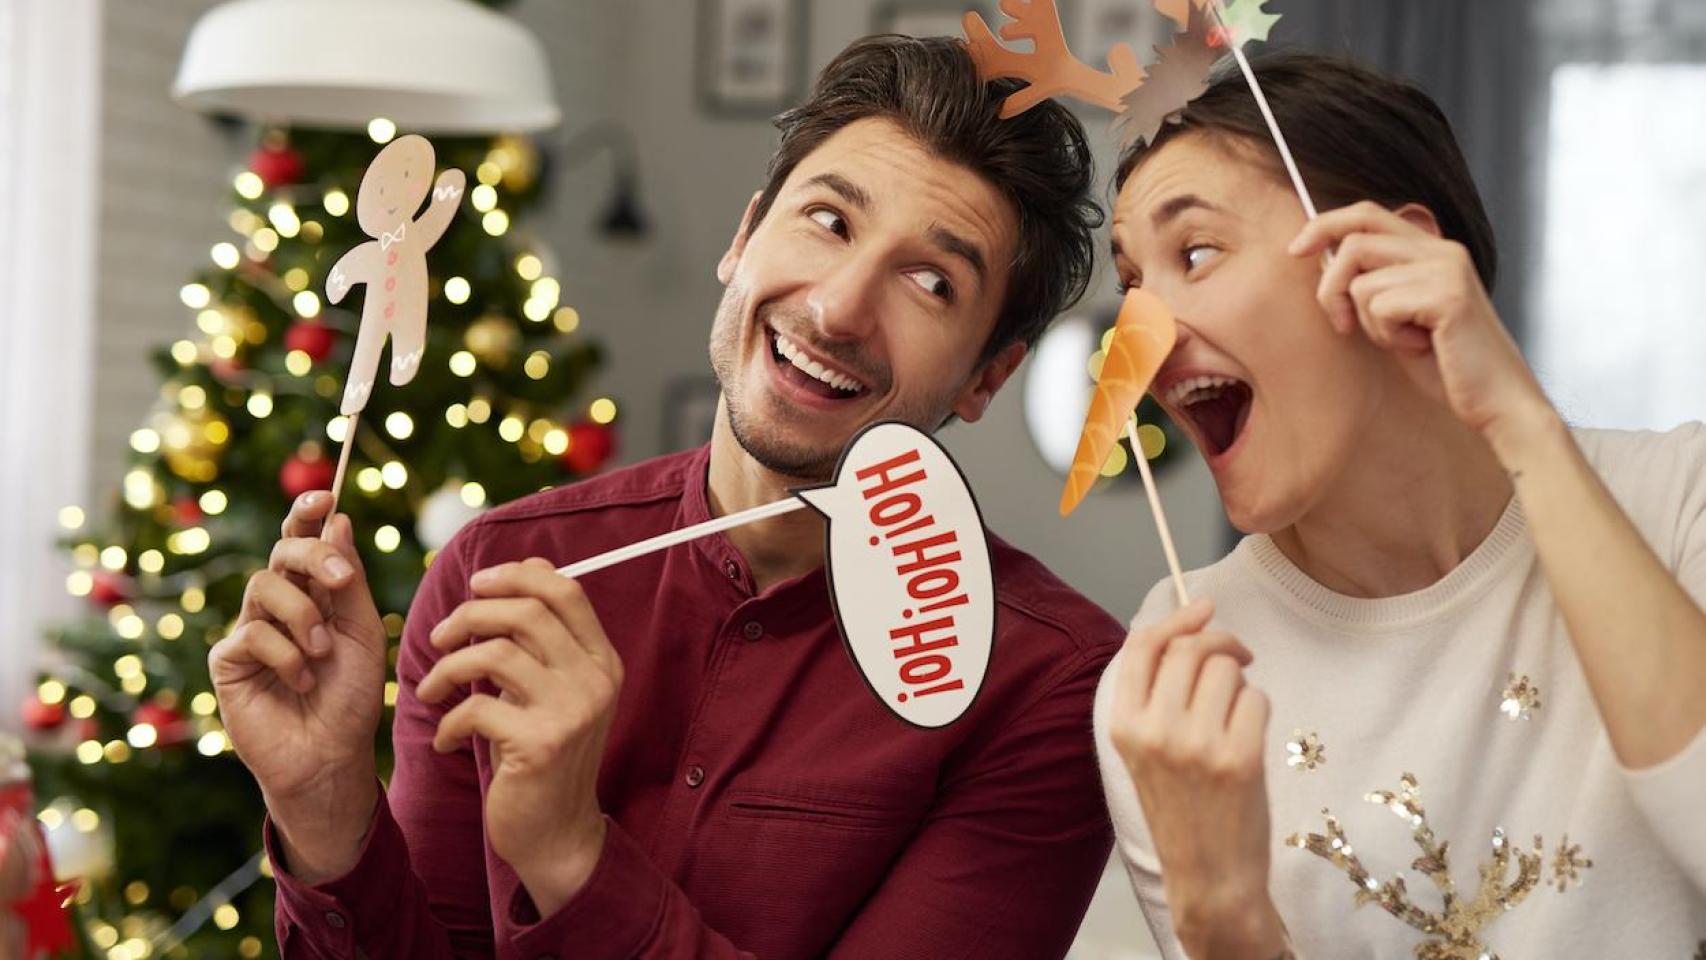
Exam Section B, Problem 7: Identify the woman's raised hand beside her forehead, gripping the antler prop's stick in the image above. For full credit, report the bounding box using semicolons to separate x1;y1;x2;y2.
1290;201;1556;450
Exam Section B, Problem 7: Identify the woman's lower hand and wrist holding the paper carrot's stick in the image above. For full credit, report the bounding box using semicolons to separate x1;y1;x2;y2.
1109;600;1286;960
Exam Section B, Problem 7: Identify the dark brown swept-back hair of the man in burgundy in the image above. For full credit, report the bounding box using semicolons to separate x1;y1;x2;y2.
752;34;1102;365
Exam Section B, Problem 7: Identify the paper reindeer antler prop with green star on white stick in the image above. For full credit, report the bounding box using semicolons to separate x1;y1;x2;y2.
960;0;1315;220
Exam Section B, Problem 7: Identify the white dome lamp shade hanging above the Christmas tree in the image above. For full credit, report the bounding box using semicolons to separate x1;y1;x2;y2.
172;0;561;133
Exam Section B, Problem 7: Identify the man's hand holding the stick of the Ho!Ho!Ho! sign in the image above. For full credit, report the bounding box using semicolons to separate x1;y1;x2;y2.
415;558;623;916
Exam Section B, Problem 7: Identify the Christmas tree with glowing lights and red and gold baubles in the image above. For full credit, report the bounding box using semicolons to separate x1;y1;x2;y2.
24;112;616;960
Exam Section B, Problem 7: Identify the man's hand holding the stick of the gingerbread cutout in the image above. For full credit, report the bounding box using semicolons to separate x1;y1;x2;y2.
208;491;386;883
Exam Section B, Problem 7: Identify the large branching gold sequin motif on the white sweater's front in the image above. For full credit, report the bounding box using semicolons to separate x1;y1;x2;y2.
1286;774;1593;960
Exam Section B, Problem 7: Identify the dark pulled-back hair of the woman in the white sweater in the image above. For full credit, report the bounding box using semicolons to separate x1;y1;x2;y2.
1114;53;1498;292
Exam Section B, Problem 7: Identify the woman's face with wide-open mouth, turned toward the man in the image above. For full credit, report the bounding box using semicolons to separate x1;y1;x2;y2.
1114;133;1394;532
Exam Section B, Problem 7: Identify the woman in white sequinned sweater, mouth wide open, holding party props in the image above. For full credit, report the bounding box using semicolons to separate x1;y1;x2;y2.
1095;56;1706;960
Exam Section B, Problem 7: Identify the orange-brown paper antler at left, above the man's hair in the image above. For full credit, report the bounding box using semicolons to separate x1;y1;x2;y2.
960;0;1143;118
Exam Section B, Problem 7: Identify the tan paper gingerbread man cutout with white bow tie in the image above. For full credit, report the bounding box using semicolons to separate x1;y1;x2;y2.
326;135;467;416
